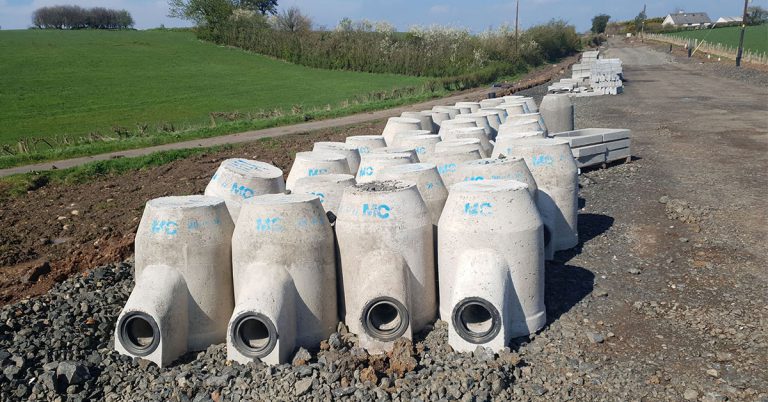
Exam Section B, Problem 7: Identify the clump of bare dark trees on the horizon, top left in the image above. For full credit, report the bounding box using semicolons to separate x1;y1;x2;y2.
32;5;134;29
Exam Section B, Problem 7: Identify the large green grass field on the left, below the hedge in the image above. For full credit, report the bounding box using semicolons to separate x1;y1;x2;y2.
0;30;426;147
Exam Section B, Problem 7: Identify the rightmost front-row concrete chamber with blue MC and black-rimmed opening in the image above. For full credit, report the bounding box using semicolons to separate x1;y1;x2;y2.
438;180;546;351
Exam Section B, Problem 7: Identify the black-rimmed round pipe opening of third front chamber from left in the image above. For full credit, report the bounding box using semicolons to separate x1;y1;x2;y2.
362;297;409;342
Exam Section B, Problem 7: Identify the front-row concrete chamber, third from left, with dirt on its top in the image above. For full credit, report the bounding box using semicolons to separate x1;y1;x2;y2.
336;181;437;353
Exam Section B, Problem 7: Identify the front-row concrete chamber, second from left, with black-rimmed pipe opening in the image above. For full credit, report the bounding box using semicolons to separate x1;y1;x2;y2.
227;194;338;364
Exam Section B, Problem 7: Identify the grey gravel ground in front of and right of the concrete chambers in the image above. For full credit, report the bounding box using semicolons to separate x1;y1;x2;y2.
0;41;768;401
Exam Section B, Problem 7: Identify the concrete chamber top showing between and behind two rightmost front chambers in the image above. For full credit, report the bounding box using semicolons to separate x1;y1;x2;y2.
379;163;448;227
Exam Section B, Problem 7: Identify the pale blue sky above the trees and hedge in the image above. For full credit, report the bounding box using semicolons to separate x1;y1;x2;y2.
0;0;768;32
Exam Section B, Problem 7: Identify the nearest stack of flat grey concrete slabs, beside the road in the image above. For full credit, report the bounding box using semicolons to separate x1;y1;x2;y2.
550;128;632;167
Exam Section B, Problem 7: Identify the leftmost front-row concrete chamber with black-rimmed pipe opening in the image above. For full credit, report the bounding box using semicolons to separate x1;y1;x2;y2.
115;195;234;367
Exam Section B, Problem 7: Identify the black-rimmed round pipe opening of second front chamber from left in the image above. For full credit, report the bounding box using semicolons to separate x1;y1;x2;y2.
232;313;277;358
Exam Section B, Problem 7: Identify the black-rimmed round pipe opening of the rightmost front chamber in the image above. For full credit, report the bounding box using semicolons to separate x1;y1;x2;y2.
452;297;501;344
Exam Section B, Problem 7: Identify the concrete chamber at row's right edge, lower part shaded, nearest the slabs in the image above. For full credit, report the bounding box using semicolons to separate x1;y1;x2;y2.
509;138;579;251
